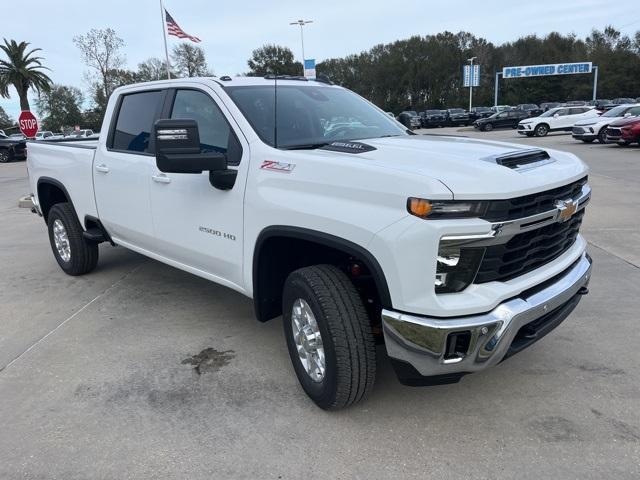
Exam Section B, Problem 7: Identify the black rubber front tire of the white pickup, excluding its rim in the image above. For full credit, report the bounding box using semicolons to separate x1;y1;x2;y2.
282;265;376;410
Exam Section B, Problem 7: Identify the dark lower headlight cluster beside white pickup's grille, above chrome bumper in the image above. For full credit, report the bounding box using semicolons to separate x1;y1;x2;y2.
434;242;484;293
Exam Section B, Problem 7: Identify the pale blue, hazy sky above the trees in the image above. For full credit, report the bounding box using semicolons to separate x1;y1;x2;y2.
0;0;640;118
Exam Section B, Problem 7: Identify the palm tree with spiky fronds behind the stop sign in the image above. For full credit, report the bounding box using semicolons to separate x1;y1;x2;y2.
0;38;51;110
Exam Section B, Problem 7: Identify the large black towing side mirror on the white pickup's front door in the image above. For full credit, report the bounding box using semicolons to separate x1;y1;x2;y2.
154;120;227;173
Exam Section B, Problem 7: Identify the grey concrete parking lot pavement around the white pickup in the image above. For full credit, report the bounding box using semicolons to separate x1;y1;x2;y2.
0;128;640;480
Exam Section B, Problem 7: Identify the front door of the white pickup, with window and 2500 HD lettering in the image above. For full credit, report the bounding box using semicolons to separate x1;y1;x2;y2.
150;87;249;287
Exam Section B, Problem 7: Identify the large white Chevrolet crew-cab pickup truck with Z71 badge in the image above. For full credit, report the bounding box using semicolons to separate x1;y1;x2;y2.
28;77;591;409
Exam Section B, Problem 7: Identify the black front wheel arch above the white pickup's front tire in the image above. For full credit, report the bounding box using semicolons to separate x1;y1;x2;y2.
252;225;391;322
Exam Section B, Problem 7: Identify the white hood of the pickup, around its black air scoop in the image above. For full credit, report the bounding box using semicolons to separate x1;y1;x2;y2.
309;135;588;200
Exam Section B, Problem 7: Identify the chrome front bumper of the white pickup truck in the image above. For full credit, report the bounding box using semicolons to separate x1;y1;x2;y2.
382;253;592;385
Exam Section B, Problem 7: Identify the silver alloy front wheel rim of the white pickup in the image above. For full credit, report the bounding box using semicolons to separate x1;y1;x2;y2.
291;298;325;382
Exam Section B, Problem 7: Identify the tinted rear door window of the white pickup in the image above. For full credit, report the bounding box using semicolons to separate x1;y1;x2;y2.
111;90;164;153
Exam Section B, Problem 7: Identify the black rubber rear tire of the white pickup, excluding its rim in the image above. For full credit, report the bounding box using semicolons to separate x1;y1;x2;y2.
47;203;98;276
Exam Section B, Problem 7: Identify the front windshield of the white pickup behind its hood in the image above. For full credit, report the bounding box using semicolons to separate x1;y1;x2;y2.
225;85;407;148
